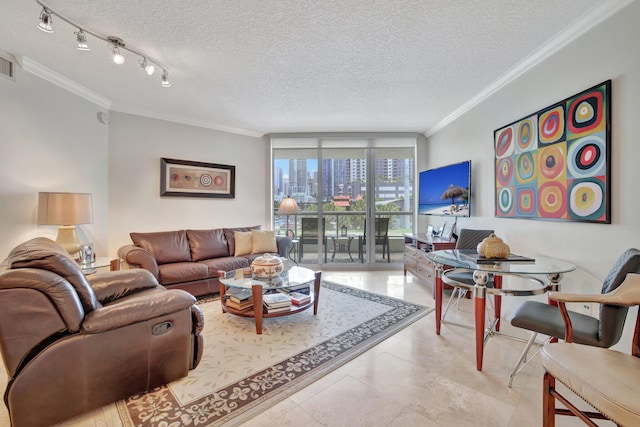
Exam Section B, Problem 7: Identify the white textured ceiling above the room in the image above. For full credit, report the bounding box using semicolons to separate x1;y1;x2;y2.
0;0;625;135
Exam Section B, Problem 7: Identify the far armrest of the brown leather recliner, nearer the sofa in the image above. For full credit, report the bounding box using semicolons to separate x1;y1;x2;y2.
87;268;158;304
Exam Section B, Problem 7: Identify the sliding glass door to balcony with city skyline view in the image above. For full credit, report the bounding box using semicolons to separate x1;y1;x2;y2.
271;134;416;264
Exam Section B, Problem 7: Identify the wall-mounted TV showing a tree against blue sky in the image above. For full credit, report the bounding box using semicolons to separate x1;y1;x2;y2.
418;160;471;216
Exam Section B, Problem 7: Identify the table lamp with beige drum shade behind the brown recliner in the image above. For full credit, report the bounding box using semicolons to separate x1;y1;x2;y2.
38;193;93;258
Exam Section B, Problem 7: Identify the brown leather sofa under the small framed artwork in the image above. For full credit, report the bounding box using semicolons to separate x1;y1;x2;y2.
118;226;292;296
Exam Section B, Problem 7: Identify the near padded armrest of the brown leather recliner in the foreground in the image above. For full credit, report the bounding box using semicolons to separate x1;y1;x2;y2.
82;289;196;334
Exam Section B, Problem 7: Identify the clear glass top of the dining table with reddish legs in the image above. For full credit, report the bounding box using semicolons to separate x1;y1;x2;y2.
426;249;576;274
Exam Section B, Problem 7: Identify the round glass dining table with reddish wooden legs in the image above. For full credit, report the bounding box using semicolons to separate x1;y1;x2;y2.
426;249;576;371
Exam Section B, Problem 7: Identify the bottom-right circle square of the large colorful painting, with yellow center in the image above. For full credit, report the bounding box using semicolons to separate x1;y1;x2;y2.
568;178;606;221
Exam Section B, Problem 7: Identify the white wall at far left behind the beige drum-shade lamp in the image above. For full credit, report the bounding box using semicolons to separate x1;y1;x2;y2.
0;64;109;261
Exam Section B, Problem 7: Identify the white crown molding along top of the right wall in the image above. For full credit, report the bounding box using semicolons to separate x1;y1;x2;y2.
424;0;635;137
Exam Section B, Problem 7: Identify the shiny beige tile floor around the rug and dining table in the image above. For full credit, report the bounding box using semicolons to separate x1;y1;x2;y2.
243;271;611;427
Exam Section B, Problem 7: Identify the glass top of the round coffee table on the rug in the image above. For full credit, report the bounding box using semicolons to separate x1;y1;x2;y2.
218;266;316;289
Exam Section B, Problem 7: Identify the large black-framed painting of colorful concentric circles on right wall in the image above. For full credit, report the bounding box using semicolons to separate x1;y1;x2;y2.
493;80;611;224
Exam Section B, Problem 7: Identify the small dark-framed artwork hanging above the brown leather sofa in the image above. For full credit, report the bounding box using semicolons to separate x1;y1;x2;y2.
160;157;236;199
